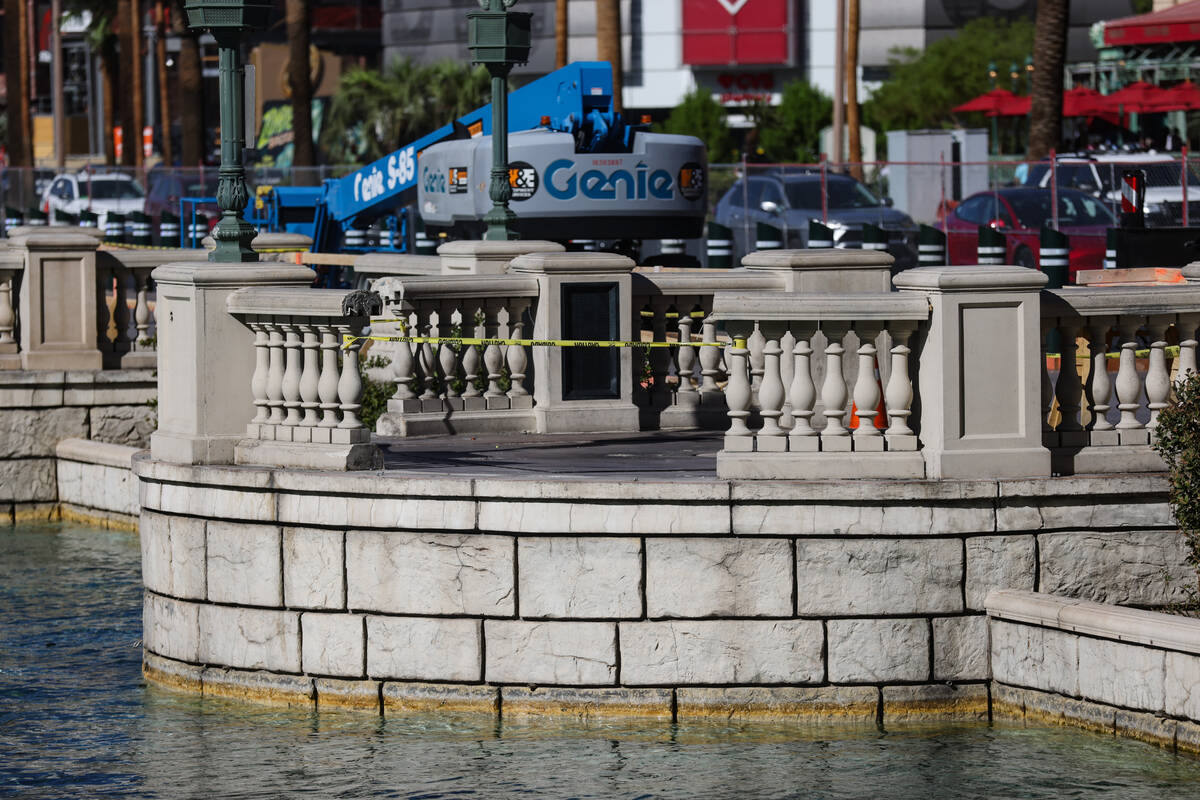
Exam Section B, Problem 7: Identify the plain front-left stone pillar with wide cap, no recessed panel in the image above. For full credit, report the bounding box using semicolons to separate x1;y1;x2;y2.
150;261;313;464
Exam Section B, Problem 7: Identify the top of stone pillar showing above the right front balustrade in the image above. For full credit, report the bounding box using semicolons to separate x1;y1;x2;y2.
742;248;895;293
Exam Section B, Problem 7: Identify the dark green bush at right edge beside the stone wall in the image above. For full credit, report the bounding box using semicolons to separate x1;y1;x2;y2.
1153;373;1200;592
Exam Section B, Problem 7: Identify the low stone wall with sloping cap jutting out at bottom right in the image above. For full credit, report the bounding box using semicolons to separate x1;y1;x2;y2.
986;592;1200;752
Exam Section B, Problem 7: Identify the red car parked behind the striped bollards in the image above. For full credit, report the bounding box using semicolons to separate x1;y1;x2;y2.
937;186;1116;283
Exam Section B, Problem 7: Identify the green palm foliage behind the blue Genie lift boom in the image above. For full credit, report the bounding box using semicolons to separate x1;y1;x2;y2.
320;59;491;164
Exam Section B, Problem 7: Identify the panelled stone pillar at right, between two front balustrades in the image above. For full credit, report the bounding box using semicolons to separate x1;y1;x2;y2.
895;266;1050;479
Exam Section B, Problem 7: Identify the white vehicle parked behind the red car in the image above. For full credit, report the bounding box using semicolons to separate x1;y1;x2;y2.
1025;152;1200;225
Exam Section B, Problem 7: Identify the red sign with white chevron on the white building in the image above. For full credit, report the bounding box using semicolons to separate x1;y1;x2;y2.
683;0;794;66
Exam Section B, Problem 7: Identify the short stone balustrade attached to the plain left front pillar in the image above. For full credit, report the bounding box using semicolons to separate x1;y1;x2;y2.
227;287;383;469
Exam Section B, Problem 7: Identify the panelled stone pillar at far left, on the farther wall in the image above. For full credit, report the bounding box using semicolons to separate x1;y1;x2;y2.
10;228;103;369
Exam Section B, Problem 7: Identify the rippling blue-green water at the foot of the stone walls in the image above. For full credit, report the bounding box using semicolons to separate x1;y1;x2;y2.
0;525;1200;800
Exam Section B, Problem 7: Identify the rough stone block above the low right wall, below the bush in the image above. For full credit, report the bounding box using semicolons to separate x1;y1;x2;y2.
1038;530;1195;606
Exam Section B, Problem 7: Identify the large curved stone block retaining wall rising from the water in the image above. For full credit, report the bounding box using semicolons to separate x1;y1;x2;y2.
134;456;1189;722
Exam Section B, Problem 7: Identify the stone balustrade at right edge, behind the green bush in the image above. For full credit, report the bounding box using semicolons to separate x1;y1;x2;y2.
1040;284;1200;473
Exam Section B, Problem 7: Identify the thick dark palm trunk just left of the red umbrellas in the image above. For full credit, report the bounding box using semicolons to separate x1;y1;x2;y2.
1028;0;1070;161
